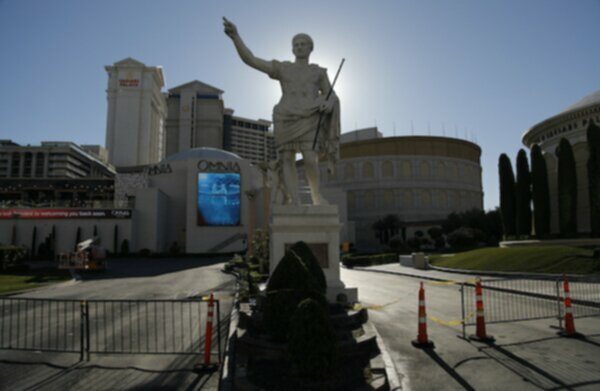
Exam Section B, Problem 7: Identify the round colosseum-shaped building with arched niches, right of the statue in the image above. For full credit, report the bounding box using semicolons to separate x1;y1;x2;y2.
322;128;483;249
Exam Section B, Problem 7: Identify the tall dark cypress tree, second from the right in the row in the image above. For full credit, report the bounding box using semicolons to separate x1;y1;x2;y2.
556;138;577;237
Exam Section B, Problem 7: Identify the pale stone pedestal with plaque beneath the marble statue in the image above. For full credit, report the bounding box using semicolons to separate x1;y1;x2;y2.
269;205;358;302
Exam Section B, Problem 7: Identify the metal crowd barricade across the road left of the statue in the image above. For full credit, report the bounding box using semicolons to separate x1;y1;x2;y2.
0;298;221;362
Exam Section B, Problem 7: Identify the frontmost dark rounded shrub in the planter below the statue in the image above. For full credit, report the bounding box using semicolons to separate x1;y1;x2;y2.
288;299;337;379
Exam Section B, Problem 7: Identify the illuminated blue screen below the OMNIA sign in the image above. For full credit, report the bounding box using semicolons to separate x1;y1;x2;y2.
198;172;240;225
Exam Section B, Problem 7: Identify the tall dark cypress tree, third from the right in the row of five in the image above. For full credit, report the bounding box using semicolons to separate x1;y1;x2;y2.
531;144;550;237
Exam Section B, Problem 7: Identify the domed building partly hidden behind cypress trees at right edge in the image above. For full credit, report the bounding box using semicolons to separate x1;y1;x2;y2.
522;91;600;233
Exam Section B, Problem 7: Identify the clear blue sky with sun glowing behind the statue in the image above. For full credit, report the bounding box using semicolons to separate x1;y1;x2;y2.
0;0;600;210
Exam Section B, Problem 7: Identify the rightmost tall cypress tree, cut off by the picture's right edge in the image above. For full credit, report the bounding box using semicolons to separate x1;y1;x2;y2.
587;120;600;238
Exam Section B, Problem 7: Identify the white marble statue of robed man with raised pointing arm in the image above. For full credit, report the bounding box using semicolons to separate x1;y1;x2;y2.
223;18;340;205
